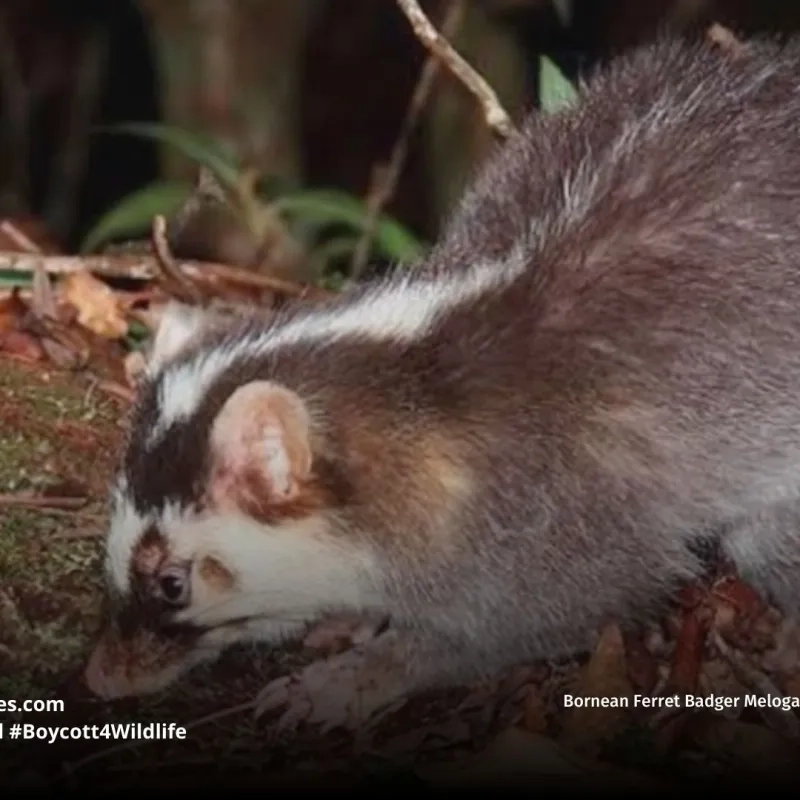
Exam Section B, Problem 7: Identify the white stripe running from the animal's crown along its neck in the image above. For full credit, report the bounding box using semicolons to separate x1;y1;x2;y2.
148;251;526;446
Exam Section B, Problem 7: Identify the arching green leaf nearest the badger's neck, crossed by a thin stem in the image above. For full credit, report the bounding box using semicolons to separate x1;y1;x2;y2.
273;189;426;261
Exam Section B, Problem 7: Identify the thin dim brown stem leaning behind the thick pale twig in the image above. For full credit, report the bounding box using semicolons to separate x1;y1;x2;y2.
350;0;464;280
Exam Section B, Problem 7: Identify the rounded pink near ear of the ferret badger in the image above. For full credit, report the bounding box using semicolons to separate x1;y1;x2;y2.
210;381;311;507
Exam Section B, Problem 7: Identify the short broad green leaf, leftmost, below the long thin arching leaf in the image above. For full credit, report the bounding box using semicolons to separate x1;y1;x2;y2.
81;181;192;253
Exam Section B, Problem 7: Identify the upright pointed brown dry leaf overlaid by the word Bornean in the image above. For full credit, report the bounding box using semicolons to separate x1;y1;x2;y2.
562;625;633;753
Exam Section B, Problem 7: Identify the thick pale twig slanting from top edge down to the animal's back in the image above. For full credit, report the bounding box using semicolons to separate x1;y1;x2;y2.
397;0;514;139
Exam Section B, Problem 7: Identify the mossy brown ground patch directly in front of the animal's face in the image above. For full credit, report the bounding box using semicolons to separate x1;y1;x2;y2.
0;361;116;697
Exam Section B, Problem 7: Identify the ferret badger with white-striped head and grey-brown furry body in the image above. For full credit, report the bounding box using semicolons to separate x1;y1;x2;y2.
87;34;800;716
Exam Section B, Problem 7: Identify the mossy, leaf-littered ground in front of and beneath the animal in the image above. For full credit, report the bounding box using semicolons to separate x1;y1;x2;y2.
0;320;800;791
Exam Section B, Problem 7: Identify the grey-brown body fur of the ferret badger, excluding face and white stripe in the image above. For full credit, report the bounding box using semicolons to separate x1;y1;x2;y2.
103;34;800;683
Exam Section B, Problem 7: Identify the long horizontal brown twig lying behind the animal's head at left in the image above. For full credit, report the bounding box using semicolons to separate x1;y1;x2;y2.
0;252;334;298
